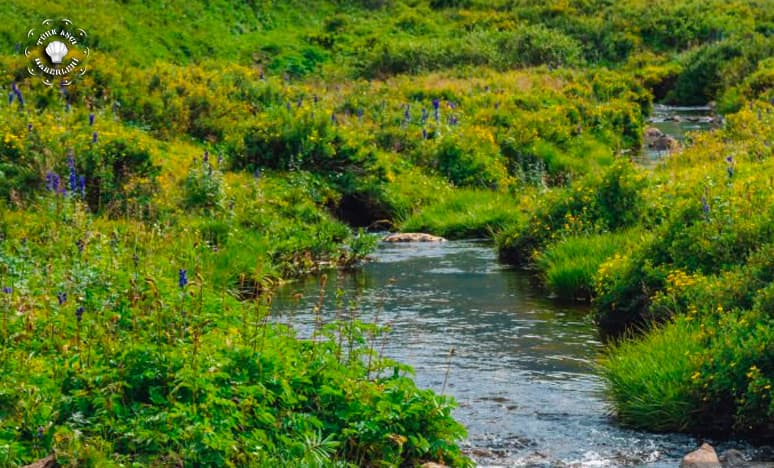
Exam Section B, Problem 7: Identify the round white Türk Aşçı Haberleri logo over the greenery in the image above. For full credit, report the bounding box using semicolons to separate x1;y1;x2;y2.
24;18;89;86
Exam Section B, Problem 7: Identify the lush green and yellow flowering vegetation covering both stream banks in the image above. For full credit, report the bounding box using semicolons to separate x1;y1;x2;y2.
0;0;774;466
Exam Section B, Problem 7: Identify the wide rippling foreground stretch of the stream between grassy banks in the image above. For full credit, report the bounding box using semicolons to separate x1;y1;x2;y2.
272;241;764;467
